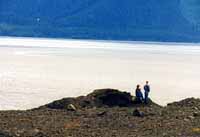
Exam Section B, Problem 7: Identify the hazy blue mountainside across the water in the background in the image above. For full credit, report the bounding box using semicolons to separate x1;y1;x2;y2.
0;0;200;42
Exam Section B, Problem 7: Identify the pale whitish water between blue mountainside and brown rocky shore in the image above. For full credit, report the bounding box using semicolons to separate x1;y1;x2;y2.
0;37;200;110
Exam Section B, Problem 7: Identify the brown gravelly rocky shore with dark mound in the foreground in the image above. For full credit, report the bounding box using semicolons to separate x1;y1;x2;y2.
0;89;200;137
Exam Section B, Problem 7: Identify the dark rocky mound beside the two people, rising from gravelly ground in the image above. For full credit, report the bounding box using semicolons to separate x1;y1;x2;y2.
46;89;157;109
